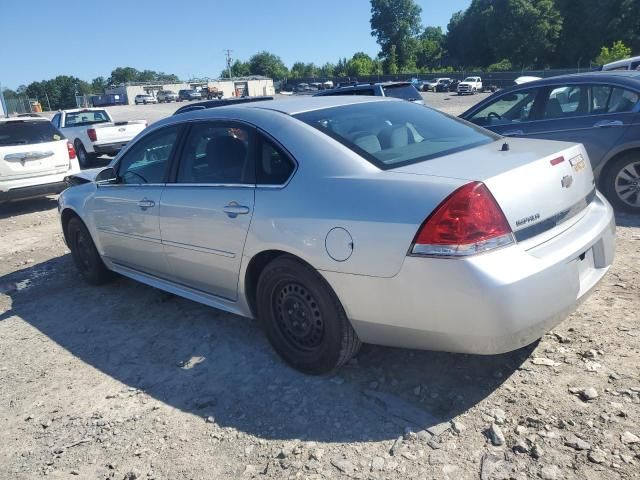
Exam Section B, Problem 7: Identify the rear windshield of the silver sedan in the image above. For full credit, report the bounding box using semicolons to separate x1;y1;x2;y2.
295;101;499;170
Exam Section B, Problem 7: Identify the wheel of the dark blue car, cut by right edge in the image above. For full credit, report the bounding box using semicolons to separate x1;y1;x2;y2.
600;151;640;213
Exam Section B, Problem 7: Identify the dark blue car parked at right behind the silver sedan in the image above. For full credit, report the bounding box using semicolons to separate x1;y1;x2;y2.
461;72;640;213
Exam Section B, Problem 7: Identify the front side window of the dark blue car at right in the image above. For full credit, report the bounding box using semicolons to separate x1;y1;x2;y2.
469;88;539;127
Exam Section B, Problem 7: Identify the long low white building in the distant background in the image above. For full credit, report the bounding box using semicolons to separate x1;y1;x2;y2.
105;76;275;105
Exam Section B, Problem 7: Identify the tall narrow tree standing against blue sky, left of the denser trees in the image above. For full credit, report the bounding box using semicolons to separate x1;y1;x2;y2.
371;0;422;69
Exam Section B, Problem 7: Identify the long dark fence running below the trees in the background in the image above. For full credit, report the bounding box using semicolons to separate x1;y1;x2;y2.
286;68;588;89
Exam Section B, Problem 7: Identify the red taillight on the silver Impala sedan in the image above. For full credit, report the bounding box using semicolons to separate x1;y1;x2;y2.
411;182;515;256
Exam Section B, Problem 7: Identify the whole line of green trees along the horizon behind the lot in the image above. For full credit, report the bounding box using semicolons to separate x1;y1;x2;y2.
4;0;640;109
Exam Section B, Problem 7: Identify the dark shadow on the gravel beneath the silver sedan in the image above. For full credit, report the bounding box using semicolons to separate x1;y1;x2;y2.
0;255;534;442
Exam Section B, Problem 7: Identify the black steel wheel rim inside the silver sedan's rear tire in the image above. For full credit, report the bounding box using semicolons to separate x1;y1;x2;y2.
274;282;324;351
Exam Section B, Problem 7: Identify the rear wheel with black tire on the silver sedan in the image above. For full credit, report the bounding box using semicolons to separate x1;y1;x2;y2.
256;255;361;375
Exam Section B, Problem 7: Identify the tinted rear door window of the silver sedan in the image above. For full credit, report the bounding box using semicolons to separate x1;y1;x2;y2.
177;122;253;184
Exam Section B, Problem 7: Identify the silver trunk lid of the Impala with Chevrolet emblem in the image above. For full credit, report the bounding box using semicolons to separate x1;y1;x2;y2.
392;139;595;240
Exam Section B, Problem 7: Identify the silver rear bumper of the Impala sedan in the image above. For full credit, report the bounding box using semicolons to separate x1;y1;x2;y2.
322;193;615;354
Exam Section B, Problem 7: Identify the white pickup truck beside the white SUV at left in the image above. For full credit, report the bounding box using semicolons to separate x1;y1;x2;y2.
51;108;147;168
